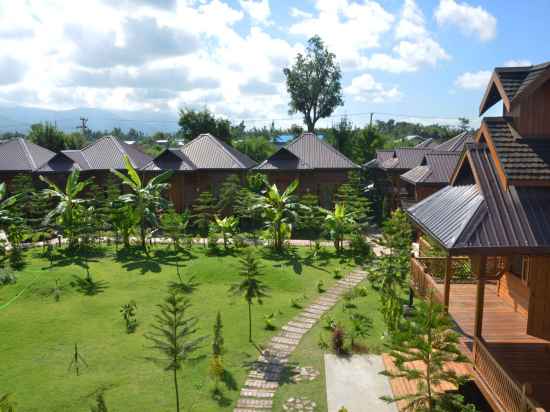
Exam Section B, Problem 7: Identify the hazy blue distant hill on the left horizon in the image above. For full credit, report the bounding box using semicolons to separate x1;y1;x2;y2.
0;106;178;134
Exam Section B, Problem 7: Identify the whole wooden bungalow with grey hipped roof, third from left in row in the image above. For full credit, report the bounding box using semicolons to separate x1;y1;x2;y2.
142;134;256;211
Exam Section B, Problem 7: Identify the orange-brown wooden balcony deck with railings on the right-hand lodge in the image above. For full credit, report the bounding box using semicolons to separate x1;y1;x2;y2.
411;257;550;412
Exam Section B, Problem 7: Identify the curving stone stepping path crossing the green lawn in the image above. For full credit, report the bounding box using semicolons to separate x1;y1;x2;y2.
234;270;367;412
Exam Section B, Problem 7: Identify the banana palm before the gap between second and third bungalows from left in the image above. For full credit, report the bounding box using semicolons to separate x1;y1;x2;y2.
111;156;172;251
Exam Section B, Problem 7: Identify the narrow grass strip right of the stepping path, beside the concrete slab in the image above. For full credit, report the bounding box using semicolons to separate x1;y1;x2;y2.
273;281;384;412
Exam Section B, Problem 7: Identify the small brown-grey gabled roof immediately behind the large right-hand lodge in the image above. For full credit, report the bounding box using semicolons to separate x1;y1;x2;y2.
401;151;460;185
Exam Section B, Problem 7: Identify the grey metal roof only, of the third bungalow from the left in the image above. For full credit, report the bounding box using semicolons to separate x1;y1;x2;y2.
143;133;256;171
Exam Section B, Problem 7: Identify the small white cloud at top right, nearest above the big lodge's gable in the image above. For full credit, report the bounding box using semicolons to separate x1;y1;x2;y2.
435;0;497;41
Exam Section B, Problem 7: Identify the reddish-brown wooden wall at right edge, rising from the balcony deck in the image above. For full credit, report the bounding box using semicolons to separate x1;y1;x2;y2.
527;256;550;339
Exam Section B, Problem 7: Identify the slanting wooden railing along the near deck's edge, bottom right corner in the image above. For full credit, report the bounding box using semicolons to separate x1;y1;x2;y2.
473;338;544;412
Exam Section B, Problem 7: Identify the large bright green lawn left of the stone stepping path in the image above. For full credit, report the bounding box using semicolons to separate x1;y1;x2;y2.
0;246;354;412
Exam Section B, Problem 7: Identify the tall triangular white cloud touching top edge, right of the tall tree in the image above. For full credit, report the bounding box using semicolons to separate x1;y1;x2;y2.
365;0;450;73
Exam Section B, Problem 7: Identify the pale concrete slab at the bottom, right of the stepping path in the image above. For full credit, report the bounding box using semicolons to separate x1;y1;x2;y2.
325;354;397;412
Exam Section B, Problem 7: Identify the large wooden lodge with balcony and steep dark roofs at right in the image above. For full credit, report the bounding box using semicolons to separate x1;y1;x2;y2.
407;63;550;412
